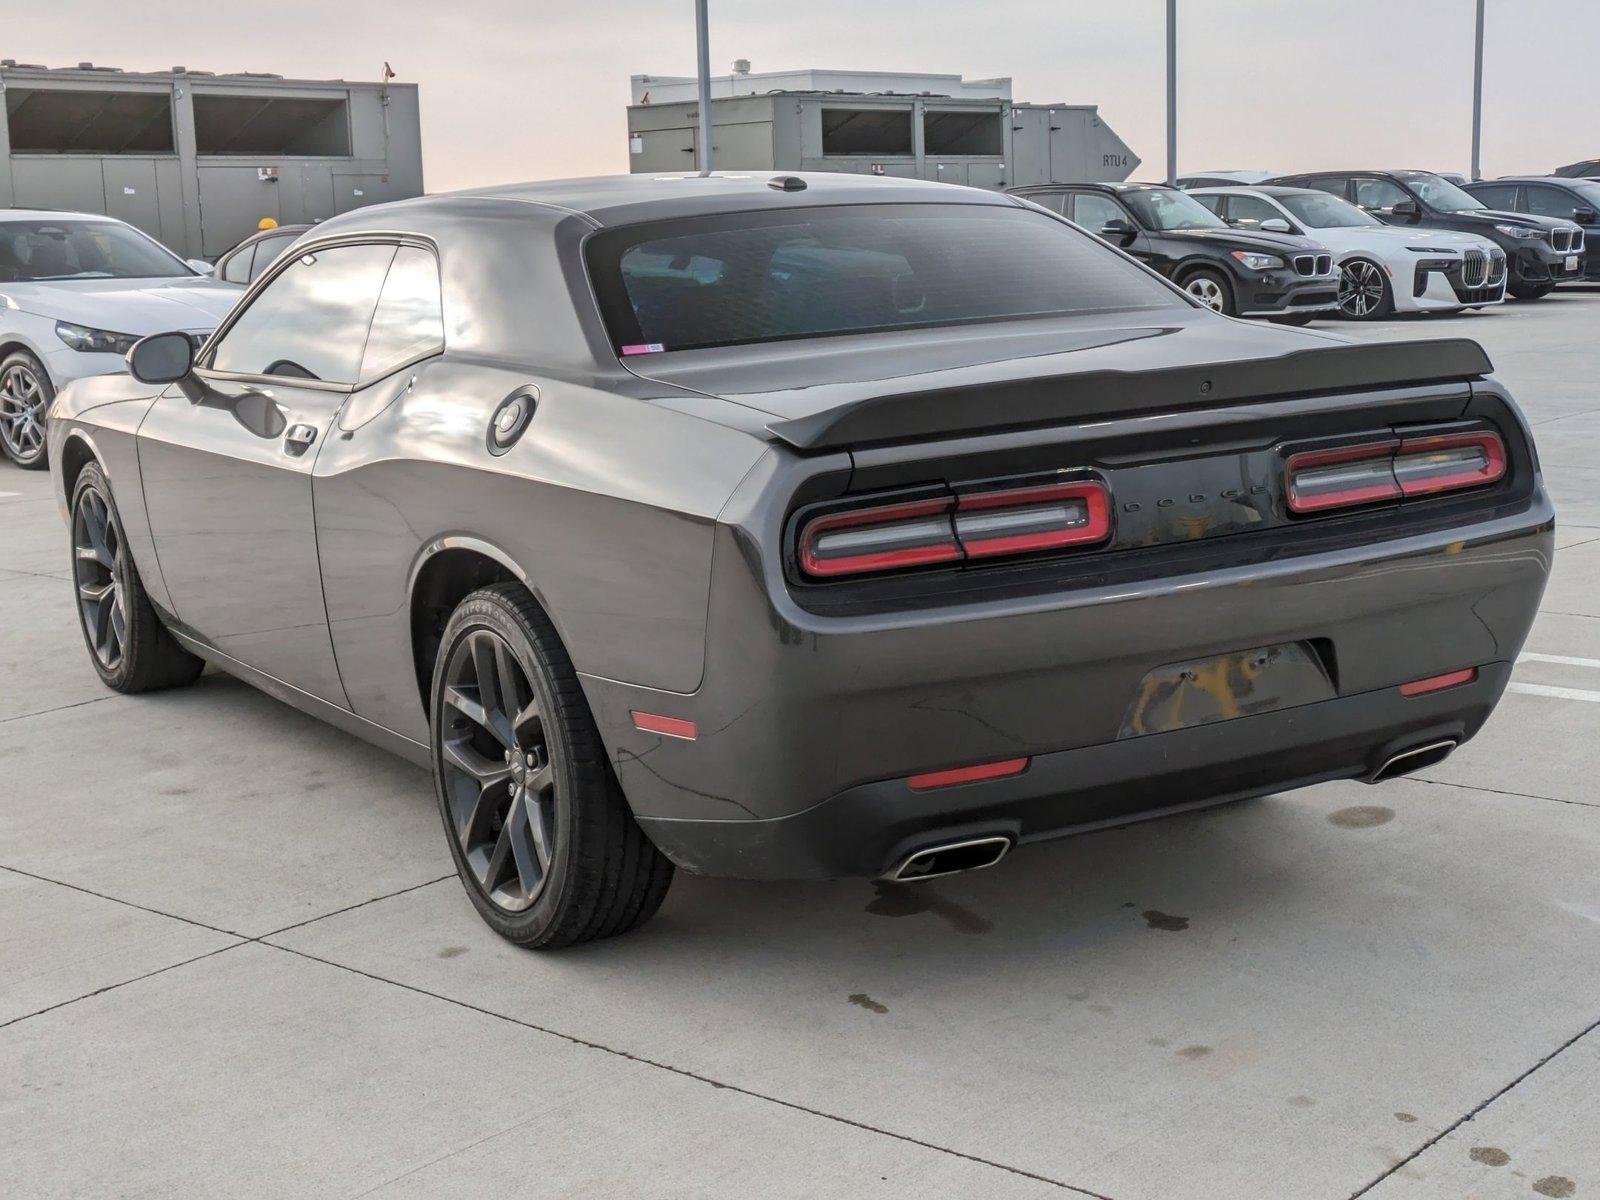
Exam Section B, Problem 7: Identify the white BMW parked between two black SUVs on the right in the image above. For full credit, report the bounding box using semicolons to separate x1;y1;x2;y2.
1189;187;1506;320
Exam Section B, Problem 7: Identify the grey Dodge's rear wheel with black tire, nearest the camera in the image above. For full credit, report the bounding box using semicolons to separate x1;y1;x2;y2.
430;584;672;950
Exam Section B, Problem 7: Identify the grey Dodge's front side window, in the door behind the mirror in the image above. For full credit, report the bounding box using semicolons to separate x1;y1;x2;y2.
211;245;395;384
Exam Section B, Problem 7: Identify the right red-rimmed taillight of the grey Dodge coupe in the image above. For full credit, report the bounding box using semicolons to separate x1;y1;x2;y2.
1285;430;1506;514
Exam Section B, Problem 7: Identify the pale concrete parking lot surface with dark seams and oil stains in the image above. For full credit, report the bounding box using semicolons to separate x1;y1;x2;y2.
0;288;1600;1200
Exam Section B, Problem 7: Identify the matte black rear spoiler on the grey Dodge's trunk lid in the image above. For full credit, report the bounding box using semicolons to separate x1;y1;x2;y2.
766;338;1493;450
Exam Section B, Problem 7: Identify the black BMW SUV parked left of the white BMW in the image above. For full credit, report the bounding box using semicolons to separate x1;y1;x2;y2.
1011;184;1339;323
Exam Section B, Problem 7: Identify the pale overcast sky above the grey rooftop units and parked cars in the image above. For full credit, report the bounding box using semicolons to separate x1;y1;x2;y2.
12;0;1600;190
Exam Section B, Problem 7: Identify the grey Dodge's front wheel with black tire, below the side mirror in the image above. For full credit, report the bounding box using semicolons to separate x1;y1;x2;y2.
70;462;205;693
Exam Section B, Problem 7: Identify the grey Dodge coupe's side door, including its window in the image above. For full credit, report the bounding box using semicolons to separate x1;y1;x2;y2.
139;242;395;707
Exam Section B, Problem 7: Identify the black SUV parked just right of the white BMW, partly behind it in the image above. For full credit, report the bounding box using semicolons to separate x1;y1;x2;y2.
1267;171;1584;299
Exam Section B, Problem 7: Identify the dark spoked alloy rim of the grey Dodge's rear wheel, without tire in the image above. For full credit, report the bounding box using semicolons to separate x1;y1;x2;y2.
438;629;555;912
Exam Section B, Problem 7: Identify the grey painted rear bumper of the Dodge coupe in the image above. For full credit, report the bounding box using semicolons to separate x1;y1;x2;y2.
582;473;1554;877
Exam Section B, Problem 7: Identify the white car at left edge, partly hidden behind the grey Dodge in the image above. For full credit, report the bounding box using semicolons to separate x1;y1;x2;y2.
0;208;242;469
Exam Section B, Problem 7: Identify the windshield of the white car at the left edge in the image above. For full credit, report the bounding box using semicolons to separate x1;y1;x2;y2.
0;221;195;283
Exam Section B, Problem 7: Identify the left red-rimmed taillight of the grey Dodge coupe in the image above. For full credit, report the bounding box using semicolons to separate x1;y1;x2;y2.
800;480;1110;579
